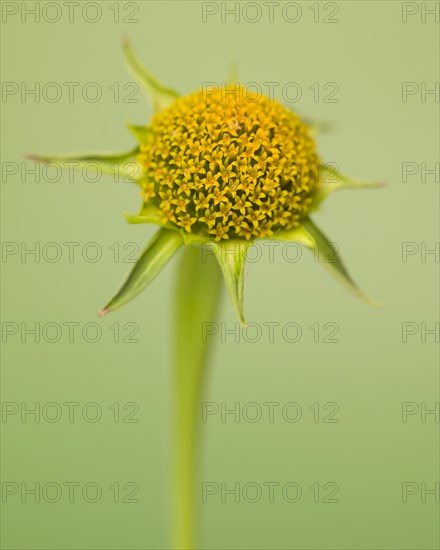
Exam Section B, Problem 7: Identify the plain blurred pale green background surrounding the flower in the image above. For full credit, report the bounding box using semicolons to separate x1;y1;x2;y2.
1;1;439;549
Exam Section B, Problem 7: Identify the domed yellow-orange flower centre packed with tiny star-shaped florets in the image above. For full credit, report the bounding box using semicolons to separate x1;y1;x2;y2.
140;88;319;240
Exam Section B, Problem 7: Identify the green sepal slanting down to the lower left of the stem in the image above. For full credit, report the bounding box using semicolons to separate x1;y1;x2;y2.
98;228;183;317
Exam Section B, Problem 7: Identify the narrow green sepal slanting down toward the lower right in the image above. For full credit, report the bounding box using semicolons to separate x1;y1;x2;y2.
273;218;382;307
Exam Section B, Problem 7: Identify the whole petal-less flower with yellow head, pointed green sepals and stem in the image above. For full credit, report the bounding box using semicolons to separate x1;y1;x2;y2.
34;38;380;548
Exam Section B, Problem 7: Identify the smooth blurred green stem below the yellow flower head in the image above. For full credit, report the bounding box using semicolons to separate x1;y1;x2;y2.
172;246;221;550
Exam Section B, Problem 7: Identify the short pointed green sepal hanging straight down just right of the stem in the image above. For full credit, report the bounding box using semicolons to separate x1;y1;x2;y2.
207;240;252;325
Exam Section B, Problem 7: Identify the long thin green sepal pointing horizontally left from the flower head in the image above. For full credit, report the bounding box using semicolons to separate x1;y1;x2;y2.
27;147;142;183
